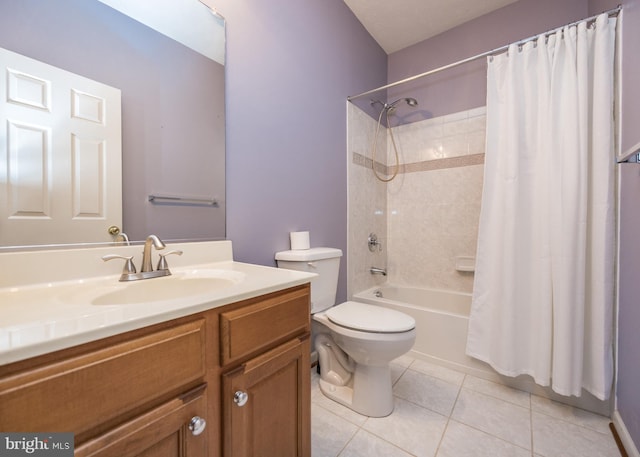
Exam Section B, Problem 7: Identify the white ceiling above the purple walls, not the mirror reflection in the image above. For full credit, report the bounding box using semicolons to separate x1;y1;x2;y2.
344;0;517;54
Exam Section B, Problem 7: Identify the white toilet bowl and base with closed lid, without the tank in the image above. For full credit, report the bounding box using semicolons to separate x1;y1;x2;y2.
313;301;416;417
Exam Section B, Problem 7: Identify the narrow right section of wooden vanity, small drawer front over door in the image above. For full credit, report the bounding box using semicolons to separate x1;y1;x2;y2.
220;289;311;457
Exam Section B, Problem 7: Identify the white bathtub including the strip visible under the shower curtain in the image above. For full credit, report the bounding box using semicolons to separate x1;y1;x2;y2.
353;284;613;416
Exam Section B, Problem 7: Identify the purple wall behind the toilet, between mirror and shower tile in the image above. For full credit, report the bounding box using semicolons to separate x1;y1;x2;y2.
216;0;387;300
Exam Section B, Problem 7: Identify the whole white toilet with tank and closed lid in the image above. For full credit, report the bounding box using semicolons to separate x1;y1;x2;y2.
276;248;416;417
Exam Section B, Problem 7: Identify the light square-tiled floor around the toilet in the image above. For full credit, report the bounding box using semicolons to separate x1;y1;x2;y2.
311;356;620;457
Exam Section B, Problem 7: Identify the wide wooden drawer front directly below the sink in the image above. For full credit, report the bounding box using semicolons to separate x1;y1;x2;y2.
0;319;206;443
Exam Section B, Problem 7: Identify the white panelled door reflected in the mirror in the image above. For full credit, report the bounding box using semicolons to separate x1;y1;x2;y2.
0;48;122;245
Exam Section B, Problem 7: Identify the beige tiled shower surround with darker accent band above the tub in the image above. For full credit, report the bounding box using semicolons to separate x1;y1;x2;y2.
348;104;485;296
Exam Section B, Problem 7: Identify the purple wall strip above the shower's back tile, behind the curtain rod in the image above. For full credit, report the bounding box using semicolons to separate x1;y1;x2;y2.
388;0;592;122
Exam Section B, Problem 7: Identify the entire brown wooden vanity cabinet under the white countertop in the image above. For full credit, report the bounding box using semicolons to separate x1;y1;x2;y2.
0;284;311;457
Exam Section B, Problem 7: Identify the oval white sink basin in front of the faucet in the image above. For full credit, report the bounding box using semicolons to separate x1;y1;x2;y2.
61;269;245;305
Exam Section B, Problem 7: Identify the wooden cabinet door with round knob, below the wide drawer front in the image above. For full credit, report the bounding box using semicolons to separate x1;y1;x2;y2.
74;385;208;457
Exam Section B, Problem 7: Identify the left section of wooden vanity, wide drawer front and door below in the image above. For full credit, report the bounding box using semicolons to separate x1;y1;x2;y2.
0;317;207;456
